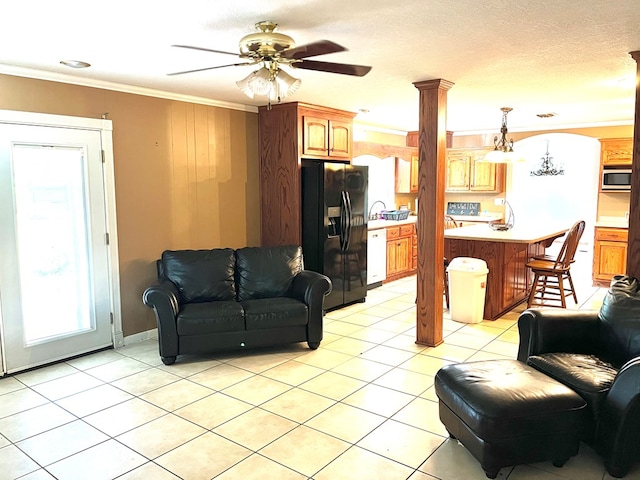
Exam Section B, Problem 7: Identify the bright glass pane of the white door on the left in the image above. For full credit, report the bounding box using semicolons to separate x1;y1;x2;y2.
12;145;93;345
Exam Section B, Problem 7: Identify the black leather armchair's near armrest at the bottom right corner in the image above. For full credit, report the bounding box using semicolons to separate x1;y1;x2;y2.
595;357;640;477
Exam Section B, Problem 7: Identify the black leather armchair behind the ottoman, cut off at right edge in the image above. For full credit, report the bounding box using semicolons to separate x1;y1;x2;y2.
518;277;640;477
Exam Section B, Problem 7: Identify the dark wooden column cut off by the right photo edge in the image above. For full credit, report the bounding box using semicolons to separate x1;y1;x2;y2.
627;51;640;279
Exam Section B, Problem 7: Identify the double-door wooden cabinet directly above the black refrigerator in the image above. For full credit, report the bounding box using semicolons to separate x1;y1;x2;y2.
300;107;355;162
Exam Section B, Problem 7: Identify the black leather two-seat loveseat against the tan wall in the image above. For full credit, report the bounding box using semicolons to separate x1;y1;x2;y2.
143;246;331;365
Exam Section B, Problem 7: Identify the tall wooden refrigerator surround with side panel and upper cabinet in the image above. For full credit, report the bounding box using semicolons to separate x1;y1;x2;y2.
258;102;356;246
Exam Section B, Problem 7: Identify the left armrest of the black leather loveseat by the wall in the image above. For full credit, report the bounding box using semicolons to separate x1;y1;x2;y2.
142;279;180;357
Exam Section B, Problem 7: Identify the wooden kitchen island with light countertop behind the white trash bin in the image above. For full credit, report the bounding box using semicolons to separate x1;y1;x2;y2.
444;225;569;320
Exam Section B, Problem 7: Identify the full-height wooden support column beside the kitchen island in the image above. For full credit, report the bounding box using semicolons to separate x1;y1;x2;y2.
414;79;453;347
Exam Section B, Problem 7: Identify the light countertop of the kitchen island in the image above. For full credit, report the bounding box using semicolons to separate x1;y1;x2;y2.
444;224;570;243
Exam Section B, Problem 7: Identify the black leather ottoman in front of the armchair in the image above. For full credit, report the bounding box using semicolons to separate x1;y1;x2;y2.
435;360;588;478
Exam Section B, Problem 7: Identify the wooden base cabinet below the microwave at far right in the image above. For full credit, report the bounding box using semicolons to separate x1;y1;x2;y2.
592;227;629;287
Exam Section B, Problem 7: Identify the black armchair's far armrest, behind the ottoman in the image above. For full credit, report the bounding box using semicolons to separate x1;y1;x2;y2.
518;308;599;362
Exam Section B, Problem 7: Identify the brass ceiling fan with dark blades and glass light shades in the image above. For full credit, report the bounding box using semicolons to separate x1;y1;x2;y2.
168;21;371;101
